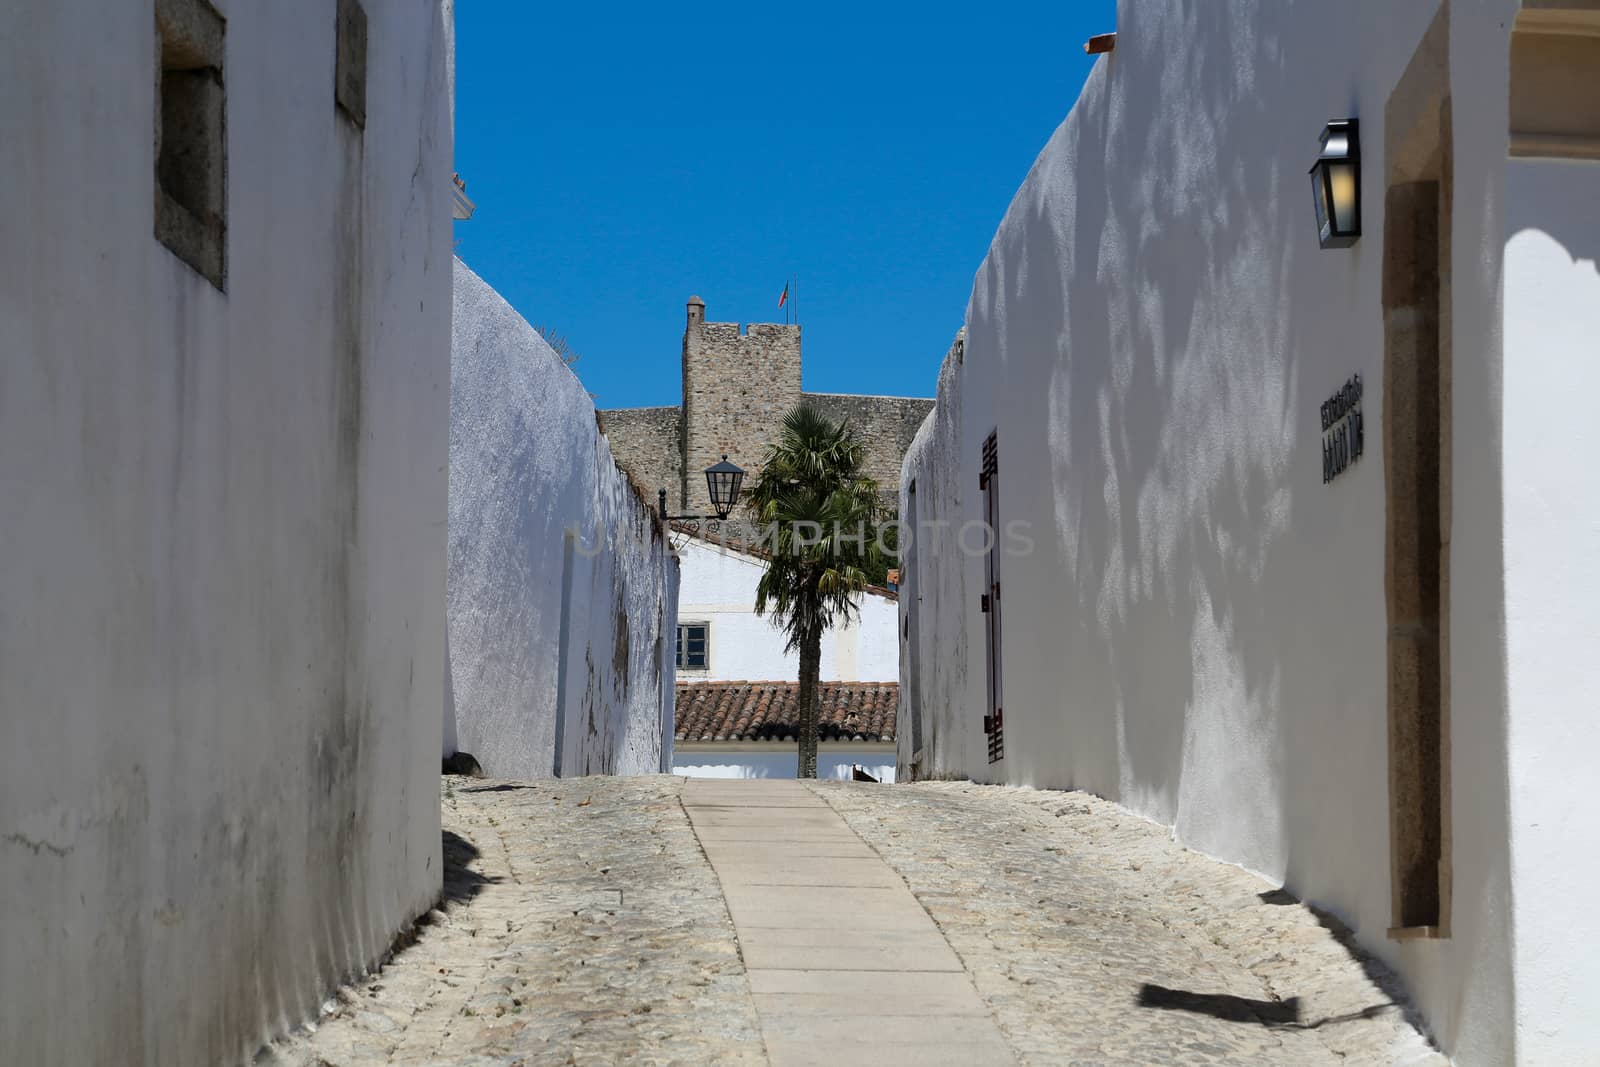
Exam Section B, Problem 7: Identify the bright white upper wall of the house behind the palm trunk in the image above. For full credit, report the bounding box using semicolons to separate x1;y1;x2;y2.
678;537;899;681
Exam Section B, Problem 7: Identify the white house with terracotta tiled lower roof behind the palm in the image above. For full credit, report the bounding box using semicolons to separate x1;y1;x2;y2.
672;526;899;781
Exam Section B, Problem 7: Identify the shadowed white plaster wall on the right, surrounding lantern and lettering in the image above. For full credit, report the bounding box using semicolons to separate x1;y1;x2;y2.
901;0;1536;1064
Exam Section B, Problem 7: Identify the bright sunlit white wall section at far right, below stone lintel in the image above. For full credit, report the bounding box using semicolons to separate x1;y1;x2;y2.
1502;160;1600;1064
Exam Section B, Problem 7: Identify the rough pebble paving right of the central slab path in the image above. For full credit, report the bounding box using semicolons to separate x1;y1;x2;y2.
814;782;1446;1067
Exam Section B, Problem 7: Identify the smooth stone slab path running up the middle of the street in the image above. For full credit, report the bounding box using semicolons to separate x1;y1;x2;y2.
683;779;1013;1067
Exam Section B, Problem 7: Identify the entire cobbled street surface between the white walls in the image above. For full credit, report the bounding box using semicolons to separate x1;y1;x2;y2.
261;776;1443;1067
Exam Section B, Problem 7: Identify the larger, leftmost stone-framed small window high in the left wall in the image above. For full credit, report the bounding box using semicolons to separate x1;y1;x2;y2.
155;0;227;290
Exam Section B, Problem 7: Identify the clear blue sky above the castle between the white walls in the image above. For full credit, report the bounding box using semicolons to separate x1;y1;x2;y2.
456;0;1115;408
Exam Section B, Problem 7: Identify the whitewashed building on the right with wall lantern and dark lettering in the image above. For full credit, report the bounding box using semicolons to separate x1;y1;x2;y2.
899;0;1600;1064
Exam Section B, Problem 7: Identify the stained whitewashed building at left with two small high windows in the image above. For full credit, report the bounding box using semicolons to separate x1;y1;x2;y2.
0;0;453;1064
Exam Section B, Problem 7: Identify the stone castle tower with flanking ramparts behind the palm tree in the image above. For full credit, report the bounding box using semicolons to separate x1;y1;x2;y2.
600;296;933;512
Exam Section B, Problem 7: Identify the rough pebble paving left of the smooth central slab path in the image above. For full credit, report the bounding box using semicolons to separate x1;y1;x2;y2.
258;776;766;1067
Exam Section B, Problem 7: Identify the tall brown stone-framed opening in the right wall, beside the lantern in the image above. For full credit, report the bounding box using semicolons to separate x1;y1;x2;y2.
1382;5;1451;939
